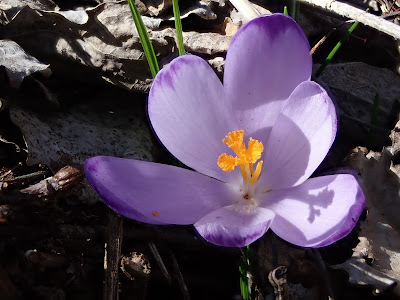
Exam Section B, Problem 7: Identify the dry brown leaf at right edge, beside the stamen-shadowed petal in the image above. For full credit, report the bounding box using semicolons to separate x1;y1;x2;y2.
337;122;400;293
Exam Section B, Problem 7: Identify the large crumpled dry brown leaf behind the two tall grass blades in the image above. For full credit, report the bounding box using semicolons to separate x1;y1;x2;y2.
0;0;230;91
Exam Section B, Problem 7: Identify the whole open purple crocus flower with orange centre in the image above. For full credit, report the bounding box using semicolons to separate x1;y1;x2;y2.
85;14;364;247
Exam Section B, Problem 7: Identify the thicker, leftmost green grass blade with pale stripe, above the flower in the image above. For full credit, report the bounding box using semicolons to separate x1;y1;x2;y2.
128;0;160;77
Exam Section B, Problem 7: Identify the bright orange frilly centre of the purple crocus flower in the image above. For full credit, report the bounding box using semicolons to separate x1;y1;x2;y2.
217;130;264;190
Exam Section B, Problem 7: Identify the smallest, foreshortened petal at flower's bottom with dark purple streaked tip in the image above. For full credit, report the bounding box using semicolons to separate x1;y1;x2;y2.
194;204;274;247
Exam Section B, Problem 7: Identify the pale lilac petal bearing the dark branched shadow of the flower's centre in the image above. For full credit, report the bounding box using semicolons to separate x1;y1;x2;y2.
260;174;365;248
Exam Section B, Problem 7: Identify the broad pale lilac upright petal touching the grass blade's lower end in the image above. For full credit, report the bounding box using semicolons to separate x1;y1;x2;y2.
148;55;240;182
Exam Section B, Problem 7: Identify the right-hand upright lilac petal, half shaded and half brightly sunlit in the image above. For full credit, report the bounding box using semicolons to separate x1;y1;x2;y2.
260;81;337;190
